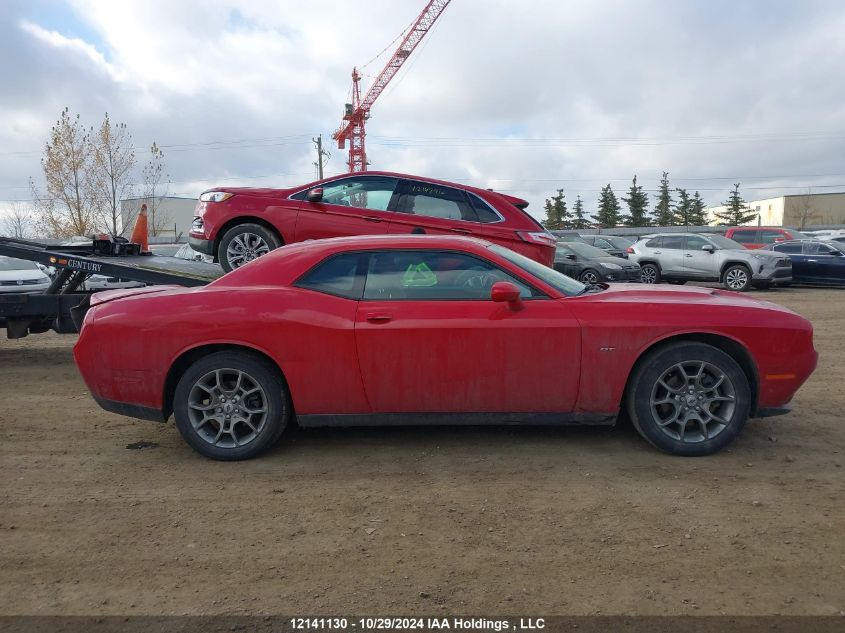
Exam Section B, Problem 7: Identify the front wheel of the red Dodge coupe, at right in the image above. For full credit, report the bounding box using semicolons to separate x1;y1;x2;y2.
625;342;751;457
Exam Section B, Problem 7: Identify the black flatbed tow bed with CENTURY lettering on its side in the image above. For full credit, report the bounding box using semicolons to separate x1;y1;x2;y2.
0;237;223;338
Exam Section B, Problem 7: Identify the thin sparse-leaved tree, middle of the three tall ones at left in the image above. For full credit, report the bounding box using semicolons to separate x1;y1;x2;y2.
92;112;135;235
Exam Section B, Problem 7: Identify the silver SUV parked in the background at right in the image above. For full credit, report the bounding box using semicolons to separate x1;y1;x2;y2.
628;233;792;291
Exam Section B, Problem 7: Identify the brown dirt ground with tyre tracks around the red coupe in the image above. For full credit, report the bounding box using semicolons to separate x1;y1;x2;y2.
0;288;845;615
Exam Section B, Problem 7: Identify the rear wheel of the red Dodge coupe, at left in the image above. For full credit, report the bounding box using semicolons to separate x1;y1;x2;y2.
173;352;291;461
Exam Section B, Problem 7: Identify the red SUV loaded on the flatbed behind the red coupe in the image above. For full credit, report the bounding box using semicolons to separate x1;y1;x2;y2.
190;171;555;272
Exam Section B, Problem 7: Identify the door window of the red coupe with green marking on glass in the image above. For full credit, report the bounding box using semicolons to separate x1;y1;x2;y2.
364;250;541;301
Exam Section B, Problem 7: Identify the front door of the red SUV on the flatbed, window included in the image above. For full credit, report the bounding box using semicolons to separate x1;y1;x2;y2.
295;176;399;242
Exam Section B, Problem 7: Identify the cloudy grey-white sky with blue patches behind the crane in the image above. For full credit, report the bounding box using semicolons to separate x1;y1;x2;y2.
0;0;845;222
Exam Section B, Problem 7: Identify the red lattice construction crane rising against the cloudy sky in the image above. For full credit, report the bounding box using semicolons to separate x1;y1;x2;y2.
332;0;451;173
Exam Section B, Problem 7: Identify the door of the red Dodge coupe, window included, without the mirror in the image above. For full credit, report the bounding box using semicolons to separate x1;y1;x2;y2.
355;250;581;414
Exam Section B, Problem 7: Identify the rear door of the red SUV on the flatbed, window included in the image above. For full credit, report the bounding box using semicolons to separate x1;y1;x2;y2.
388;180;481;236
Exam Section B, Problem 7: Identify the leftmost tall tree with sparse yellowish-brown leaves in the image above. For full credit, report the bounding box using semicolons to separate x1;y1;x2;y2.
35;108;98;237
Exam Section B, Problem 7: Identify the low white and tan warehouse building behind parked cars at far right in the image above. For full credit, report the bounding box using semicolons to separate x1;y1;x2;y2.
706;193;845;229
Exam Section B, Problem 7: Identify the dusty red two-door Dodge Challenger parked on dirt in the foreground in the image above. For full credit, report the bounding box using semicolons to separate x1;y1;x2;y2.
74;235;817;460
